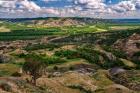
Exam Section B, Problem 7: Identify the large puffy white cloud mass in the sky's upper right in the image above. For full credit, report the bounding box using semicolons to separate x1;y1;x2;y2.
70;0;140;16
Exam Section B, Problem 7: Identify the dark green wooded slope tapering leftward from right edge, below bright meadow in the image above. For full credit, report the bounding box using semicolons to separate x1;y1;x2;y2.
52;29;140;46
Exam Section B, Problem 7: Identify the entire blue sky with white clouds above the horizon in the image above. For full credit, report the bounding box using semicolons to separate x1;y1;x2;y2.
0;0;140;19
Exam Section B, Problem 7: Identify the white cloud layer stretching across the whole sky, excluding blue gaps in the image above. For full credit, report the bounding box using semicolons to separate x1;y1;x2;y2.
0;0;140;17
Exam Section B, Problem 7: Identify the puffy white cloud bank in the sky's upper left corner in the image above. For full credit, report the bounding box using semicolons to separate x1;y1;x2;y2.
0;0;58;14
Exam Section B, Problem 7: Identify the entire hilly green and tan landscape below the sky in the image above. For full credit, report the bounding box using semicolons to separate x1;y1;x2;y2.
0;18;140;93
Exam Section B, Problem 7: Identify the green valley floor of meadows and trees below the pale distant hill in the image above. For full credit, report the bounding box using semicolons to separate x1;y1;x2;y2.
0;22;140;45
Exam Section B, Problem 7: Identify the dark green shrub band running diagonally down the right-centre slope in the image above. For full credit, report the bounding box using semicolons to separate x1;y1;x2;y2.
78;48;124;69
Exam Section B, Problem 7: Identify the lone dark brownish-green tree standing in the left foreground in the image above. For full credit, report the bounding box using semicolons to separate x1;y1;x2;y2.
23;58;47;85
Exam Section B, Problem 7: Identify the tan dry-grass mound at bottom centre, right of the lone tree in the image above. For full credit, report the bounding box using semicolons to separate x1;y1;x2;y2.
37;71;97;93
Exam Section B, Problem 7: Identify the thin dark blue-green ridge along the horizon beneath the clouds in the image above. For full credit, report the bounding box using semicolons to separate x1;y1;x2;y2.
0;17;140;24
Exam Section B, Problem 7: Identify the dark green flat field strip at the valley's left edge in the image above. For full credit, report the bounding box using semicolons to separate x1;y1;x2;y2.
0;29;63;41
